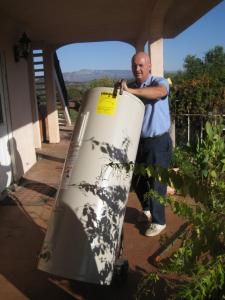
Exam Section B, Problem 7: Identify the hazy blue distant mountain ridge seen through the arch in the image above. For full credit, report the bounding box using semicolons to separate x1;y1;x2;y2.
63;69;132;82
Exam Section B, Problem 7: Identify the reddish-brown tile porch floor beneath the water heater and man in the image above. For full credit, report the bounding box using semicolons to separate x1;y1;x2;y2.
0;130;184;300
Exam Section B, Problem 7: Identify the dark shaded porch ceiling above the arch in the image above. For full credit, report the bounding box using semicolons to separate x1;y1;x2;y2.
0;0;221;46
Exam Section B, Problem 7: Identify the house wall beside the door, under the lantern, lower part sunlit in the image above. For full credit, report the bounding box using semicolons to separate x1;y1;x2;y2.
0;18;36;180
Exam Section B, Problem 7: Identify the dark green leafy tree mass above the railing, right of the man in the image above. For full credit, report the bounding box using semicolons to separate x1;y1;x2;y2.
171;46;225;115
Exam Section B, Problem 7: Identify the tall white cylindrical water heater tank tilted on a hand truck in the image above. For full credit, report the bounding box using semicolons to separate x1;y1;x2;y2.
38;87;144;285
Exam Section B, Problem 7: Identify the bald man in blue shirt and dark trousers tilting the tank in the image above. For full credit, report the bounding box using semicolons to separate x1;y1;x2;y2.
119;52;172;236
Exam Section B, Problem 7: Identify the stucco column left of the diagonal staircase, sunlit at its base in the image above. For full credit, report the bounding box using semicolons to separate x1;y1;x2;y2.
44;48;60;143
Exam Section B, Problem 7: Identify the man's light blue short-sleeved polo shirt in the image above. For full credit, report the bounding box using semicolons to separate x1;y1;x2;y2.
129;74;171;138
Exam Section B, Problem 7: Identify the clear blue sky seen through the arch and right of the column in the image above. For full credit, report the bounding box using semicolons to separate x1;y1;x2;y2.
57;1;225;73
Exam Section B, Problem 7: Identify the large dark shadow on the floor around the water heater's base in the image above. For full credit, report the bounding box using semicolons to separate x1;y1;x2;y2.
0;198;168;300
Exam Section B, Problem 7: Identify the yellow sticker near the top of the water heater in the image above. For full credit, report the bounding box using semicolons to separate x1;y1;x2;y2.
96;92;117;116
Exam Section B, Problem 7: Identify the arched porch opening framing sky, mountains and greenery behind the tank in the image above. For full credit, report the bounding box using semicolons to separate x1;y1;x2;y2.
56;42;135;122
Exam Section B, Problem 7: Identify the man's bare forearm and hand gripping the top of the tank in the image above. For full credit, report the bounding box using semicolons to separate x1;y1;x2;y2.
120;80;168;100
